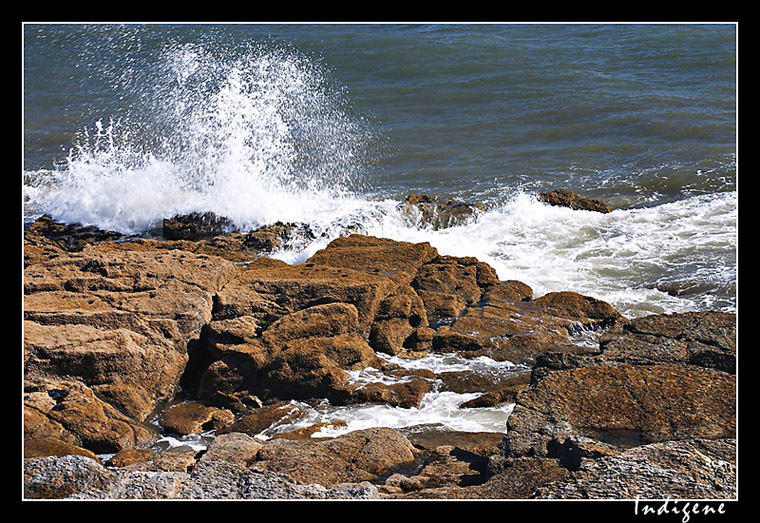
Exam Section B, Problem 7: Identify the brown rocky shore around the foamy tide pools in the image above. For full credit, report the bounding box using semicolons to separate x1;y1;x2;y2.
23;192;737;499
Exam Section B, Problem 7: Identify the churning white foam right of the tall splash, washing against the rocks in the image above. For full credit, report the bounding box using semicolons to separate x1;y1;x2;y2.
274;192;738;316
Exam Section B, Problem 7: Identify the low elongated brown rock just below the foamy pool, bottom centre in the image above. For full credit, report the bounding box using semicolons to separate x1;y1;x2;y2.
255;428;422;486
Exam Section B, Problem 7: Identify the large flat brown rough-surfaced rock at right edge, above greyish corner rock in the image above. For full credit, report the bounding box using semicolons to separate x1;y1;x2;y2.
505;364;736;456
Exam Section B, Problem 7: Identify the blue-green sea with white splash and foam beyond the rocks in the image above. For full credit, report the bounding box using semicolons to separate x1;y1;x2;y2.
21;23;738;442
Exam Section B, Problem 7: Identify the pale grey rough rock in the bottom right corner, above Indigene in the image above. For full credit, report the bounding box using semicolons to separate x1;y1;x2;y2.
535;439;737;499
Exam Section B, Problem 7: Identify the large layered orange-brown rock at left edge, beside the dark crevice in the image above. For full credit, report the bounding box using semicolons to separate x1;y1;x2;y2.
23;243;237;453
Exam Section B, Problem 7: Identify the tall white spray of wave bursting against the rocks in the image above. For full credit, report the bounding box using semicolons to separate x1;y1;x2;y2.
24;44;380;232
